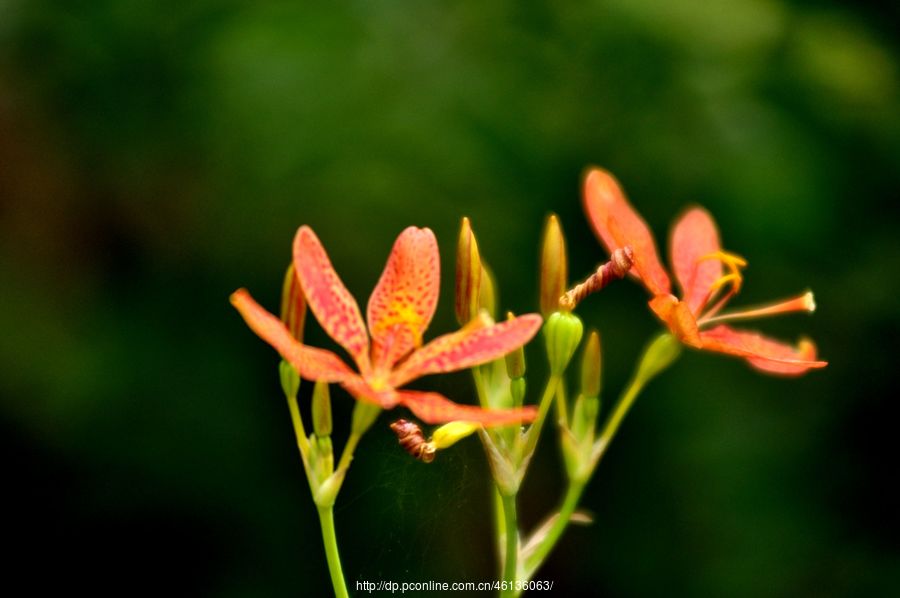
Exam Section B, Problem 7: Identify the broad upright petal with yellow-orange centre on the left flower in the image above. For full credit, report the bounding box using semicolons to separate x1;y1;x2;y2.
367;226;441;368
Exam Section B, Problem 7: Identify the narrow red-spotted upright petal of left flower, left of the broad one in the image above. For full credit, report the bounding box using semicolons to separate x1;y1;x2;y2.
294;226;369;373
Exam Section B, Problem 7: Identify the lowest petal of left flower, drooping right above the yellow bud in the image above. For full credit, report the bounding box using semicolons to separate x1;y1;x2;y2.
397;390;537;426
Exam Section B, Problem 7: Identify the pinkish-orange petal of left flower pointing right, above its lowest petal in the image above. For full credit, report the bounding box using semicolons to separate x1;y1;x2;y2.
391;312;541;386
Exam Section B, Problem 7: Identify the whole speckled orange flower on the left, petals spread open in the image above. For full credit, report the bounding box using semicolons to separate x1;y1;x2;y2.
231;226;541;425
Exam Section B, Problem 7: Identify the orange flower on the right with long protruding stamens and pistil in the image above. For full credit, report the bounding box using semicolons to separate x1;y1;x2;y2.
584;168;827;375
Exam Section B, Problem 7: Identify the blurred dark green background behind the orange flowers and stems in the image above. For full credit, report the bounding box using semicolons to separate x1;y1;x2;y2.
0;0;900;596
